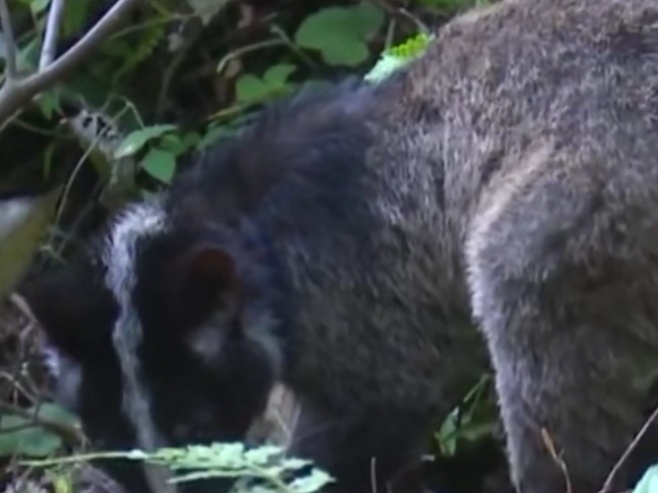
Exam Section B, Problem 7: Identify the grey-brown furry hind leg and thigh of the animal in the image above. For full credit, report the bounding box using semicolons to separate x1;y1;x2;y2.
468;151;658;493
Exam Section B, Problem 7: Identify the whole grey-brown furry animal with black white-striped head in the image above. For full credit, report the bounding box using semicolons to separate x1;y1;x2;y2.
28;0;658;493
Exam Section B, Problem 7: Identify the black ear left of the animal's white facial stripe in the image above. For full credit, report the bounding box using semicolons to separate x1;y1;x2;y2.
24;269;118;361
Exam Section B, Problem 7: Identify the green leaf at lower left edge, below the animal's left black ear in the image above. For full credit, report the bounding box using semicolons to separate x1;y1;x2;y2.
0;414;62;457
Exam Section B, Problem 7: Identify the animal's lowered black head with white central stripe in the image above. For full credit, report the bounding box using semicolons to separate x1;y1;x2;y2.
28;199;280;491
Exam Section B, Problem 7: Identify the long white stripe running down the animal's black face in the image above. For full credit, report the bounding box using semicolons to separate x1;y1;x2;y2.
103;202;177;493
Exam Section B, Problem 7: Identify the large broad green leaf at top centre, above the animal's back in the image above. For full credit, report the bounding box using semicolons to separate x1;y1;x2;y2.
295;2;385;67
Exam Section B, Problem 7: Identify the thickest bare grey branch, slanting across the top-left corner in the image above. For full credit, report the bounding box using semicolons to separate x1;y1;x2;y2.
0;0;143;128
